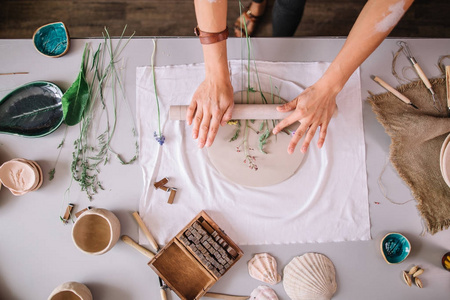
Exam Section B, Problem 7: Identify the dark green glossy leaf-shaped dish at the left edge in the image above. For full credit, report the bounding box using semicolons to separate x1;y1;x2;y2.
0;81;63;137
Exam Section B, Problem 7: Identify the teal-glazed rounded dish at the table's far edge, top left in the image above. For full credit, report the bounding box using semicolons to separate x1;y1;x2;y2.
33;22;70;57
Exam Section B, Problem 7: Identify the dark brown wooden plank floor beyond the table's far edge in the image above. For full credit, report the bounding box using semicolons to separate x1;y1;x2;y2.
0;0;450;38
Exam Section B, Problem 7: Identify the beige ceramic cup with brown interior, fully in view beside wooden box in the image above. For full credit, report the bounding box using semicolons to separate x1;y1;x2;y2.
72;208;120;255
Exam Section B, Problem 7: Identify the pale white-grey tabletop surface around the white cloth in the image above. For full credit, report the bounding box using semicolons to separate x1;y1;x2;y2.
0;38;450;300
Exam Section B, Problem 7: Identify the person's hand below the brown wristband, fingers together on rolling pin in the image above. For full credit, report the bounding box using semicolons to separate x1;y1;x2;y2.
186;77;234;148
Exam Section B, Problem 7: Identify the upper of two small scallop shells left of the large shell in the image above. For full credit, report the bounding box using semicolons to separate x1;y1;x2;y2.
247;253;281;285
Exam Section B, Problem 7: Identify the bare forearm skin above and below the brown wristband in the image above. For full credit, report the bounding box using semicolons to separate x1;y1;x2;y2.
194;0;229;80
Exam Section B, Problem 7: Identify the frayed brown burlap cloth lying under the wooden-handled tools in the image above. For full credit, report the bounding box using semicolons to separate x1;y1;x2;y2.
368;78;450;234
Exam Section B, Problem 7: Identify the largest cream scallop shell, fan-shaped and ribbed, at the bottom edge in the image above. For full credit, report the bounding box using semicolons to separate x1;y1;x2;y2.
283;253;337;300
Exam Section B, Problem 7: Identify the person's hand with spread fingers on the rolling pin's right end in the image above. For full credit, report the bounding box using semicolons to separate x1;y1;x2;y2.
273;80;340;154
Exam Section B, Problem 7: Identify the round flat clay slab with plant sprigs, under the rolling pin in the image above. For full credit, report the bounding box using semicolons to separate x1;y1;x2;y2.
208;92;304;187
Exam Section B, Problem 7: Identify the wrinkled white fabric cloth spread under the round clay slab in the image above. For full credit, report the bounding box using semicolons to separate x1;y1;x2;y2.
136;61;370;245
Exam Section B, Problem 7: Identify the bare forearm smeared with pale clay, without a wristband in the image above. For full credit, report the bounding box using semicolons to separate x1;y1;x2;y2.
323;0;413;92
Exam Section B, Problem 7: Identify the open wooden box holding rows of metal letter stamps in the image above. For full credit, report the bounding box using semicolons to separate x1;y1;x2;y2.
149;211;243;300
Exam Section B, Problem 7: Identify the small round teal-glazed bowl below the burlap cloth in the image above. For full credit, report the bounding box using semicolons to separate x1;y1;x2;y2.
380;232;411;264
